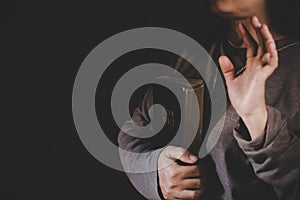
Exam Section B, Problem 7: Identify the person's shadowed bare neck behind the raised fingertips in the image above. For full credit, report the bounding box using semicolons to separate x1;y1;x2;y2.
228;16;285;48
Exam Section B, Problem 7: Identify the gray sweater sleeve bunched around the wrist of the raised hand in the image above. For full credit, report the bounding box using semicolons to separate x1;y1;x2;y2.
234;106;300;199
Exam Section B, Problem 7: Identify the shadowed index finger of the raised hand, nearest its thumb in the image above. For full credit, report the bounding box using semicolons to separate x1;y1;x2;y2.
238;23;256;58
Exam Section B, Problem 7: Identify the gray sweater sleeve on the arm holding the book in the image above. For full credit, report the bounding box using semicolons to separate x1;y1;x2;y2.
118;87;163;199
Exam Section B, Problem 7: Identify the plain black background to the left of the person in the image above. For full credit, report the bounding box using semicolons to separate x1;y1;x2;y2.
4;0;299;199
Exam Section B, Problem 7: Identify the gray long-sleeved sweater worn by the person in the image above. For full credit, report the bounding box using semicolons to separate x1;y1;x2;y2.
118;39;300;200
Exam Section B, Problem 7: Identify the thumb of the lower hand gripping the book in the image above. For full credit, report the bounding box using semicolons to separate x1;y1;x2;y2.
167;146;198;164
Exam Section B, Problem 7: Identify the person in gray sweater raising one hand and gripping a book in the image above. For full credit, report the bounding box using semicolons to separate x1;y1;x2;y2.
118;0;300;200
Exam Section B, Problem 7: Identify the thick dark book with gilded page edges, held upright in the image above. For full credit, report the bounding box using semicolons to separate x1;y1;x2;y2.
154;76;204;155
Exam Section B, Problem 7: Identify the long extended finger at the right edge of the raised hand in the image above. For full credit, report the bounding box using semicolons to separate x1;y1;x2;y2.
261;24;278;67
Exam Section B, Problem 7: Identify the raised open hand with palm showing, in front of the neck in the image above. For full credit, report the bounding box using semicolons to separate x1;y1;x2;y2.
219;16;278;139
